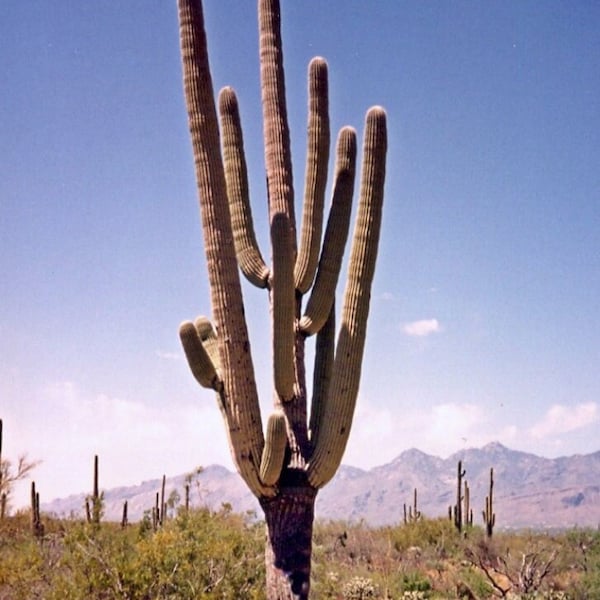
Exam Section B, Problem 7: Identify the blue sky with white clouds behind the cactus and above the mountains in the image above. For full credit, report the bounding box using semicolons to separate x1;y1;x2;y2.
0;0;600;503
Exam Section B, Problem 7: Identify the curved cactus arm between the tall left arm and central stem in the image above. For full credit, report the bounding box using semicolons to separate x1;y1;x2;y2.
219;87;269;288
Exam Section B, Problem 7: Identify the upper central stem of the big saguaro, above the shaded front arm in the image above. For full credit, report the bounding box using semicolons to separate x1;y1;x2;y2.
258;0;296;239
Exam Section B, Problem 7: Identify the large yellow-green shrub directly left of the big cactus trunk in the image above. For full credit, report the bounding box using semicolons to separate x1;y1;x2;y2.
47;510;264;600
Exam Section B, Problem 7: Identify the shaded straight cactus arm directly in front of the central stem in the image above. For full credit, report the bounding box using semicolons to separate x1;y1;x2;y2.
271;213;296;402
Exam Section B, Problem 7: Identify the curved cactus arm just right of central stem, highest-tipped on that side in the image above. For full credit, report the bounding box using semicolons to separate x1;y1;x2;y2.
294;57;330;294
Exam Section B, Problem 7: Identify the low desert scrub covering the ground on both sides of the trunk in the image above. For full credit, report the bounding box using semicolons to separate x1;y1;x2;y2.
0;506;600;600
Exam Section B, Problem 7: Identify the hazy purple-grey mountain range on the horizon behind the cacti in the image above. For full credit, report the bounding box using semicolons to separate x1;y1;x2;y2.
42;442;600;528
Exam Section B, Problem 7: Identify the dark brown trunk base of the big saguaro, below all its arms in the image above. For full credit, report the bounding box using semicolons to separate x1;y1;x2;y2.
261;484;317;600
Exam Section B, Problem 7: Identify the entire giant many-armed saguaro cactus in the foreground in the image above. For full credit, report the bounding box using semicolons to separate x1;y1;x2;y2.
179;0;387;600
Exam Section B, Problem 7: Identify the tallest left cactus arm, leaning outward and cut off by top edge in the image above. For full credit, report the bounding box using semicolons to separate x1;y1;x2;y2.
179;0;272;495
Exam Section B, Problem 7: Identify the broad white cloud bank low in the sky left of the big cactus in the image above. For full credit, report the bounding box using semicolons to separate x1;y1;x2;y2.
5;382;233;506
